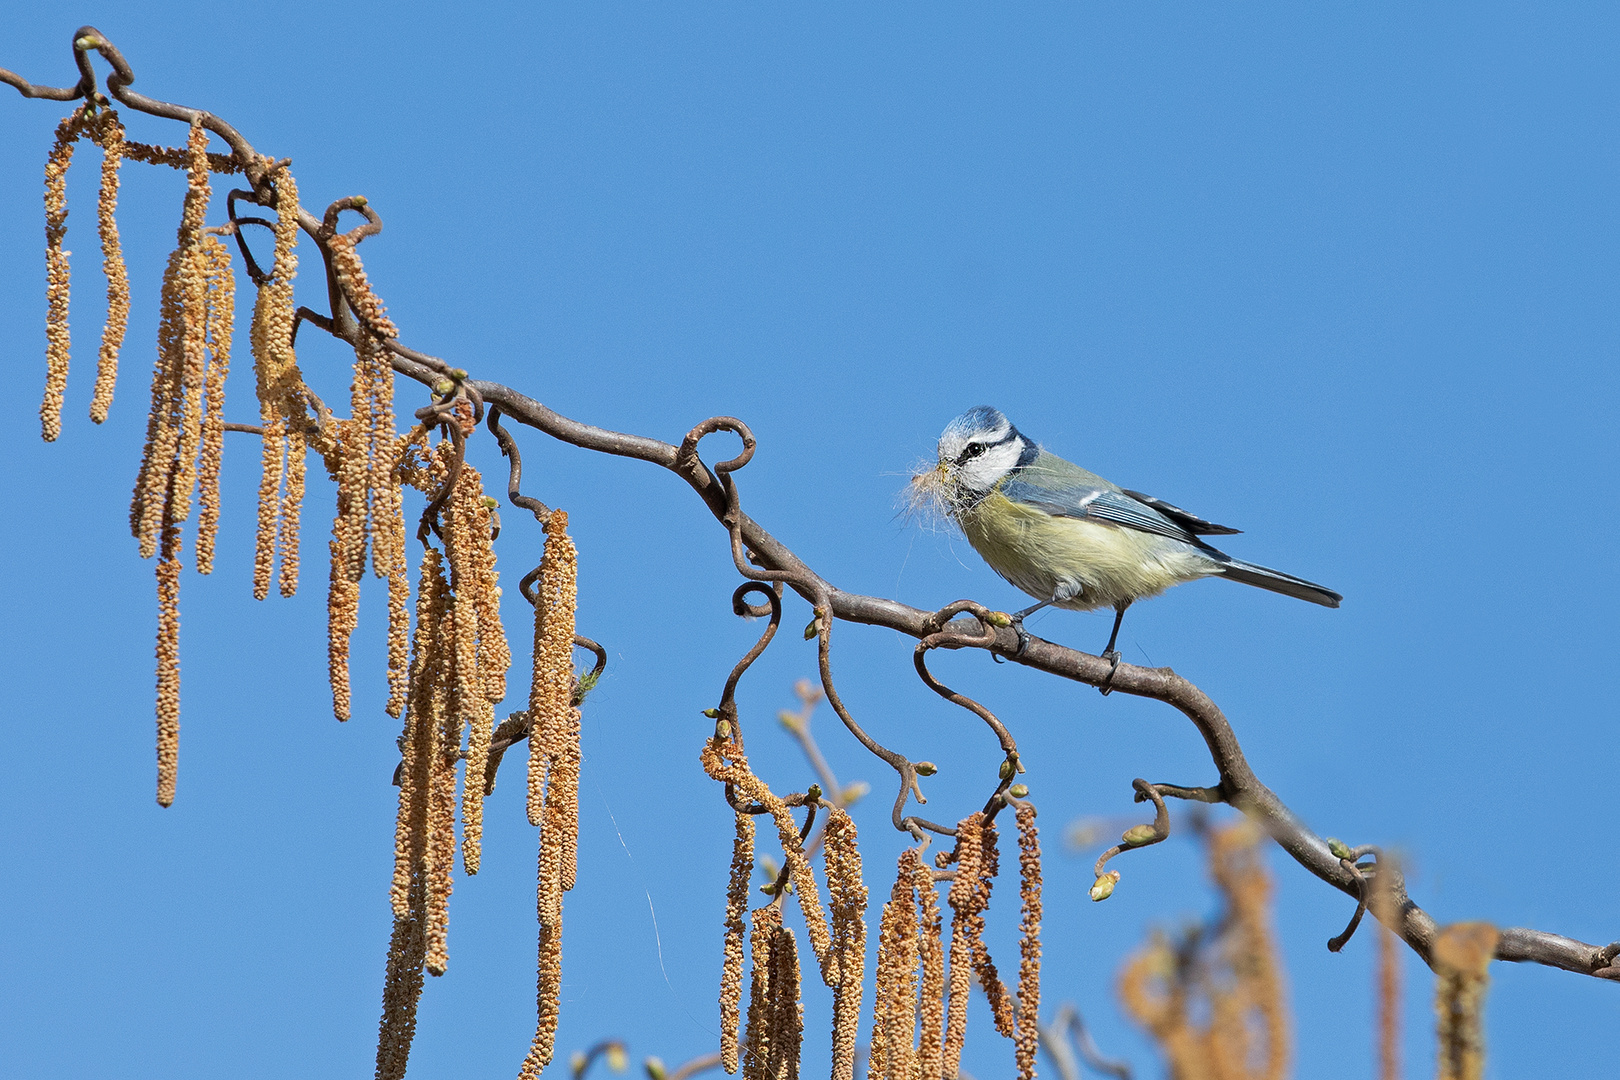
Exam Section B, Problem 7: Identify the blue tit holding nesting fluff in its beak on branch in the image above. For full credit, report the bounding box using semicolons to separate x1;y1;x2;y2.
917;405;1343;669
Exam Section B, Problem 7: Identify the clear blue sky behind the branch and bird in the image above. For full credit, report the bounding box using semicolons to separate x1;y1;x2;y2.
0;0;1620;1080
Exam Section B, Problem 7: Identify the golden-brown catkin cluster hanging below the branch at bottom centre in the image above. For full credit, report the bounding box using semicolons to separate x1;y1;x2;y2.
701;737;1040;1080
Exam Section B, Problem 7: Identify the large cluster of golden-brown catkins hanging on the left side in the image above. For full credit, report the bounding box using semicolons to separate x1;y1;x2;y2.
41;105;580;1077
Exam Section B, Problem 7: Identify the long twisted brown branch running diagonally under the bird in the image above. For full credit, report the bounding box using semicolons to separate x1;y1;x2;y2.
0;26;1620;980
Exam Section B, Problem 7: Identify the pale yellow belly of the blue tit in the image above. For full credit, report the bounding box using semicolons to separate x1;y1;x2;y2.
959;492;1220;610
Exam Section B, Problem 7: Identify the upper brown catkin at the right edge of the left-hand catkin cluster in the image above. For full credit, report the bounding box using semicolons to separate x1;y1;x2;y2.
528;510;578;829
